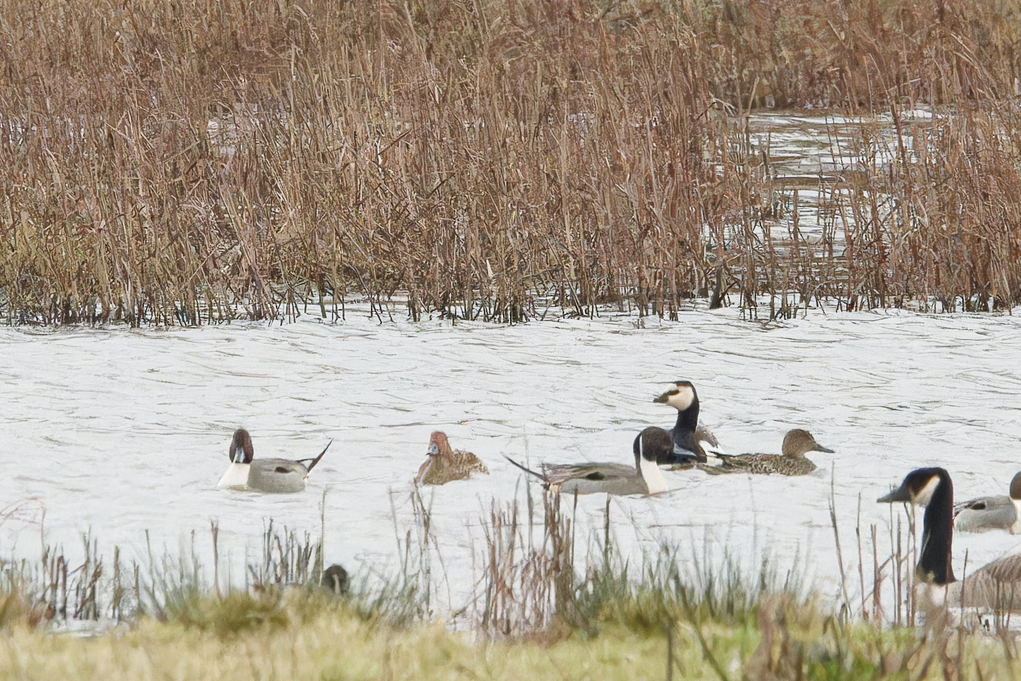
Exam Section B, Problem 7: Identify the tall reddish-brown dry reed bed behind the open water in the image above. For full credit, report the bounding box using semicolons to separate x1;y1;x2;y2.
0;0;1021;324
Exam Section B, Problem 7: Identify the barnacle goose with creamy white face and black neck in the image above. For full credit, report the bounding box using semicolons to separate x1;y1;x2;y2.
632;381;720;466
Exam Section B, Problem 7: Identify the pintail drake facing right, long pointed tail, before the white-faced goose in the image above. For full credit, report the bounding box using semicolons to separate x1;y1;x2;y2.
504;434;667;495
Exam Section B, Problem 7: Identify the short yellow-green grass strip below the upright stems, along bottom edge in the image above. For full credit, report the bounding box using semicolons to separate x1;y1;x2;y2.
0;588;1021;680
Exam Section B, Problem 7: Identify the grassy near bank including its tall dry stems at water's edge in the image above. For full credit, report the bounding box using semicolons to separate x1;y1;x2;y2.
7;495;1021;681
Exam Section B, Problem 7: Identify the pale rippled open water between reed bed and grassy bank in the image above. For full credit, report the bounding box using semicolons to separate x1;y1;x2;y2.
0;308;1021;618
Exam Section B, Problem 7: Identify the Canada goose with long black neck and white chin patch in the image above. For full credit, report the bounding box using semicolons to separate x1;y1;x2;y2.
878;468;1021;613
